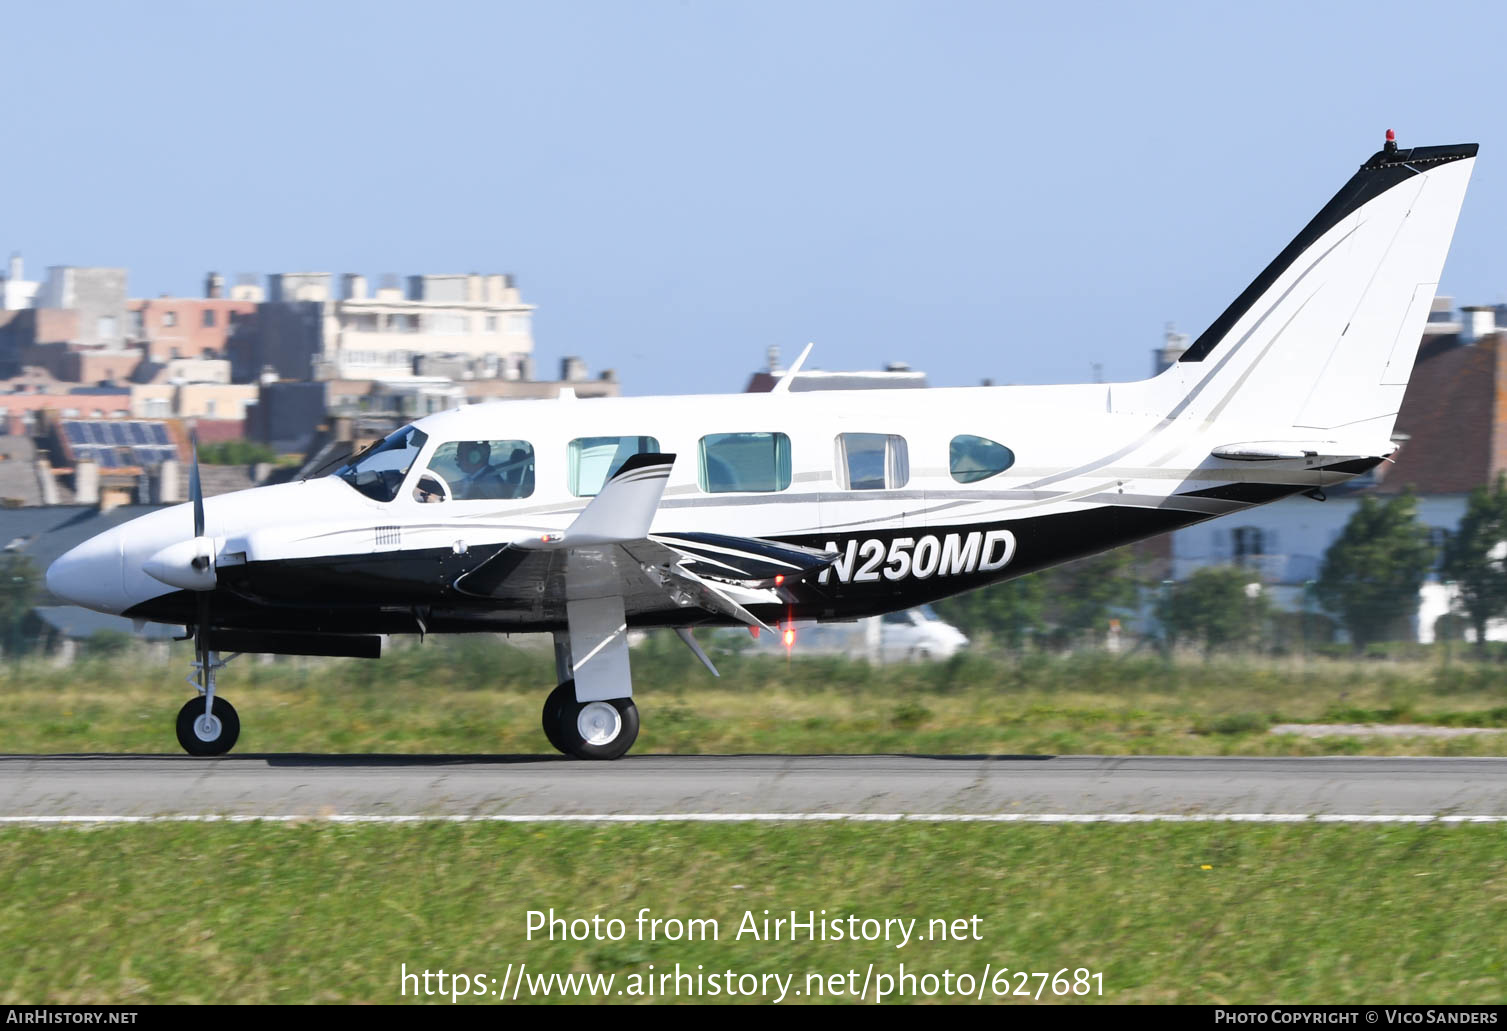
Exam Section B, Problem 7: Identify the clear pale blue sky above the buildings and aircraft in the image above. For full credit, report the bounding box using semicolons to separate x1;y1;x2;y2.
0;0;1507;393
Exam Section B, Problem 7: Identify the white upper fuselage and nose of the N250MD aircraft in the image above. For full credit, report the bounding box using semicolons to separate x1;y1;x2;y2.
50;381;1344;618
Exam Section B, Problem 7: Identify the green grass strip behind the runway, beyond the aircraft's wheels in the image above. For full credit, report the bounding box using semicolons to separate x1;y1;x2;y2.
0;638;1507;755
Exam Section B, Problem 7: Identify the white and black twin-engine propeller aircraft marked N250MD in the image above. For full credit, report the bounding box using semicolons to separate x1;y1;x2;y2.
47;131;1477;760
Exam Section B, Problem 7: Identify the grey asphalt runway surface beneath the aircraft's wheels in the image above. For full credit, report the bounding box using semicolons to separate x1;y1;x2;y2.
0;754;1507;823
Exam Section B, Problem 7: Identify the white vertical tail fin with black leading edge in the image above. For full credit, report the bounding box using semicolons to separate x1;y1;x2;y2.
1157;142;1477;442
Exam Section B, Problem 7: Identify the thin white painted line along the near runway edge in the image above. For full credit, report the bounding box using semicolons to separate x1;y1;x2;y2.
0;812;1507;826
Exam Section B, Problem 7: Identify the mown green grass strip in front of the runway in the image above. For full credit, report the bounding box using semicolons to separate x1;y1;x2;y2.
0;823;1507;1004
